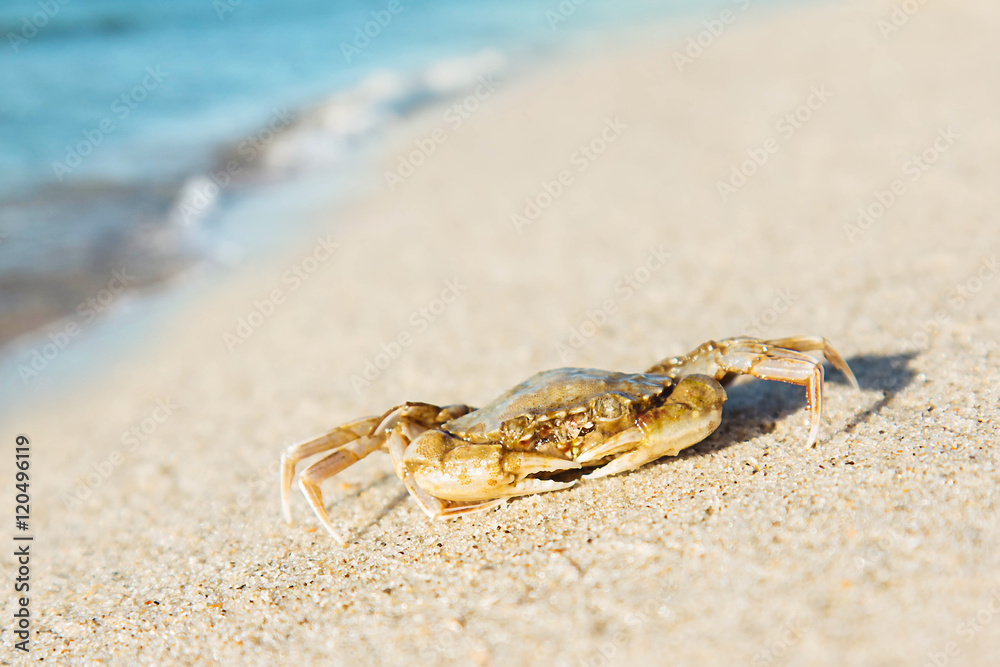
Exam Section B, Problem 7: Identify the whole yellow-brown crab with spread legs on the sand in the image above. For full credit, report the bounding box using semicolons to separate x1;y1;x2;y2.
281;336;858;544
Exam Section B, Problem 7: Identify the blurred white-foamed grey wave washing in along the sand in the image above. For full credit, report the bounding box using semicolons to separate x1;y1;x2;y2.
0;50;508;348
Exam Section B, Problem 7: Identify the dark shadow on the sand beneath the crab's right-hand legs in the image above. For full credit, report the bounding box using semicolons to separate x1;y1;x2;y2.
676;353;916;464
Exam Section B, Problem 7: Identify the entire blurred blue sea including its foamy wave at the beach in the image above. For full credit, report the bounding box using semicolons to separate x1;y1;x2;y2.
0;0;745;345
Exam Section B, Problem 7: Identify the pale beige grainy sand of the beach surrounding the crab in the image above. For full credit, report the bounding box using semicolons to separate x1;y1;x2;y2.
0;0;1000;666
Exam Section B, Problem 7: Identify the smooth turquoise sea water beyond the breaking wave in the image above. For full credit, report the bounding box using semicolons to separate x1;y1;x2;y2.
0;0;708;195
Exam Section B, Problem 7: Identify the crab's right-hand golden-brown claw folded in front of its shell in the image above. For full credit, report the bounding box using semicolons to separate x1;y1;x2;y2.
577;375;726;479
